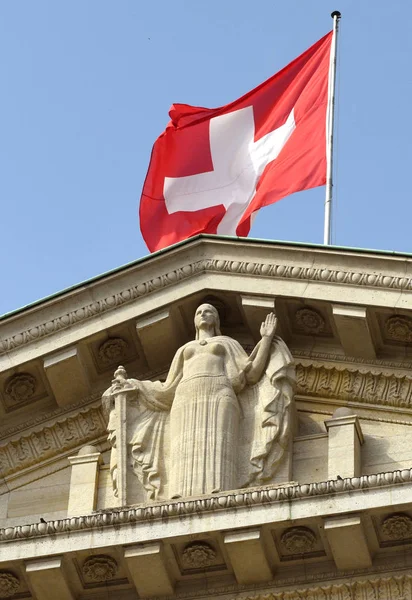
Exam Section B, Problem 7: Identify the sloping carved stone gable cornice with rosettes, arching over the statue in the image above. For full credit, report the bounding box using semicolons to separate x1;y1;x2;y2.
0;236;412;488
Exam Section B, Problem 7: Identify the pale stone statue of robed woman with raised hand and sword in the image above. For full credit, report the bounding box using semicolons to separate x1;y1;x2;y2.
103;304;295;499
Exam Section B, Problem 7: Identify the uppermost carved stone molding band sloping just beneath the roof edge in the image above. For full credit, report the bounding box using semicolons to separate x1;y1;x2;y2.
0;238;412;356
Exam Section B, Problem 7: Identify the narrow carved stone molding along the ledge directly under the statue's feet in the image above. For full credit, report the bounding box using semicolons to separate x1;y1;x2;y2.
0;469;412;542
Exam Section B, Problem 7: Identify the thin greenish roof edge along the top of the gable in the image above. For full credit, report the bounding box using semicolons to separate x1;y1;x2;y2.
0;233;412;321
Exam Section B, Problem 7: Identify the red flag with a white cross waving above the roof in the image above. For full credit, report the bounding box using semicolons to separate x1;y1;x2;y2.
140;32;332;252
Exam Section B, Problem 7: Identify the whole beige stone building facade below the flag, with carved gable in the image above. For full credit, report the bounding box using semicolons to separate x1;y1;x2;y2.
0;236;412;600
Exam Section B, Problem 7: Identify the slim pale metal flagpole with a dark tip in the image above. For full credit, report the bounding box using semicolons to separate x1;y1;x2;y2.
323;10;341;245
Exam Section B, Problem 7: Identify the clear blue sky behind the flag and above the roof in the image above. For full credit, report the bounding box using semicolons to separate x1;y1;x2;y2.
0;0;412;314
